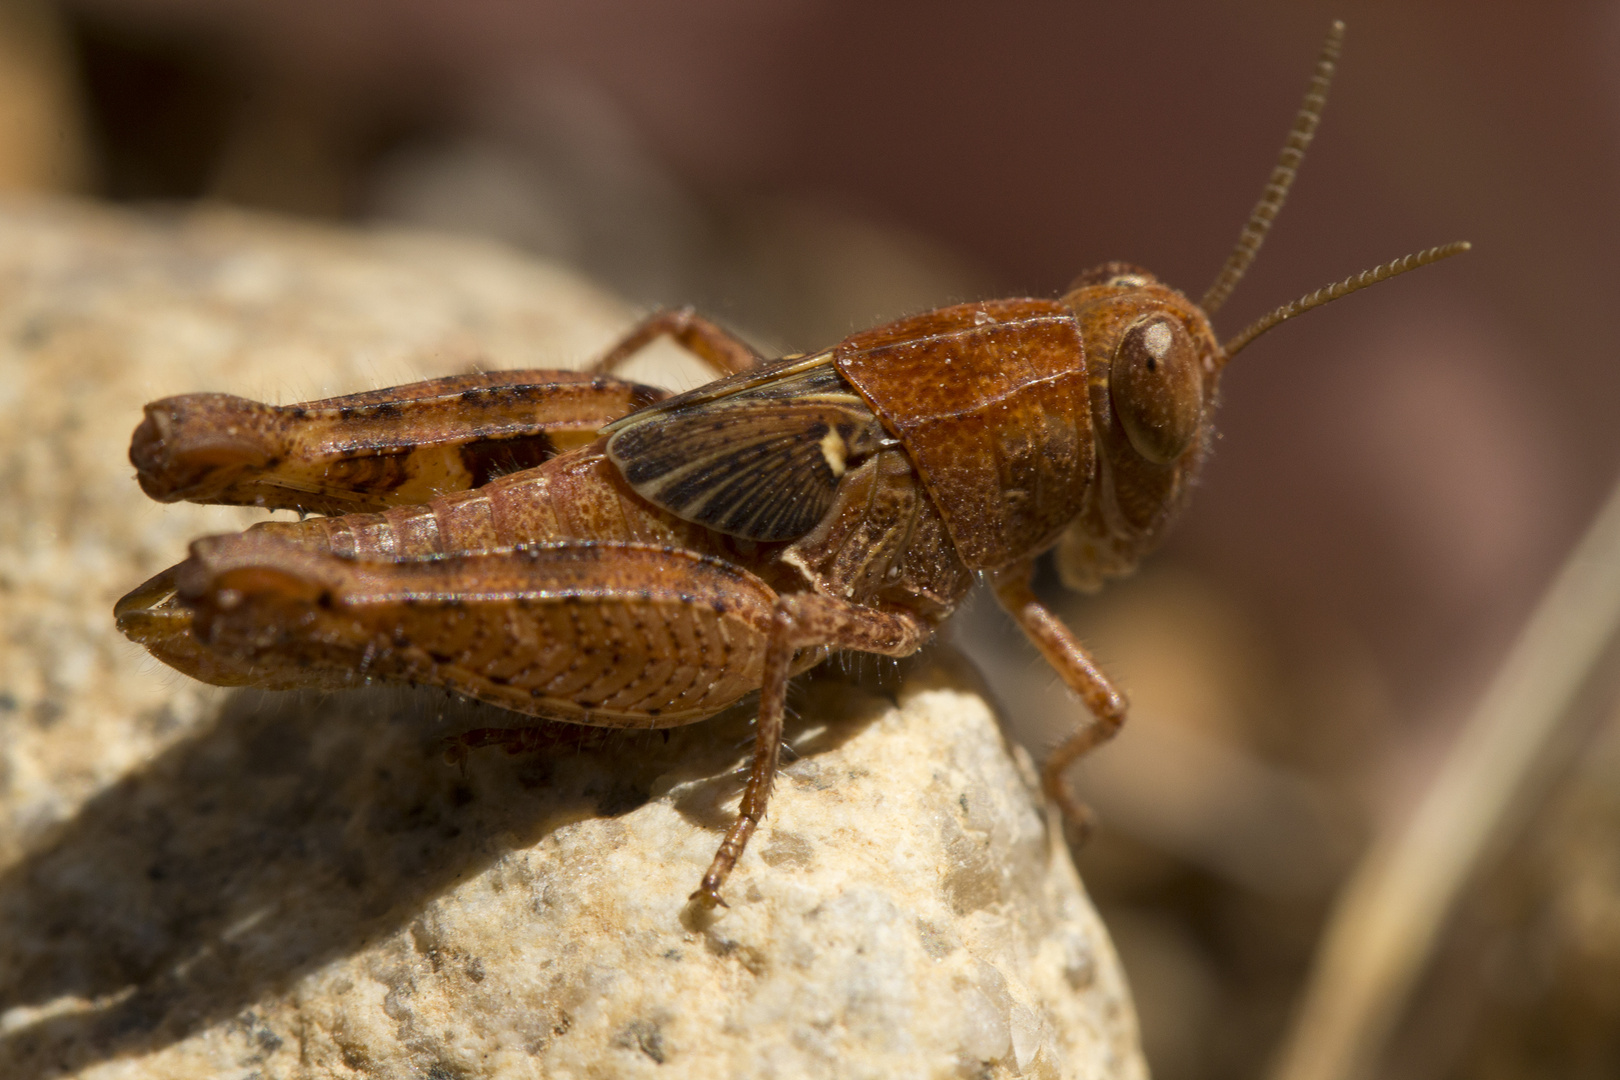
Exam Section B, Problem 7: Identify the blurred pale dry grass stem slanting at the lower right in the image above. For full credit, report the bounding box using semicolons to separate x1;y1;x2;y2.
1273;469;1620;1080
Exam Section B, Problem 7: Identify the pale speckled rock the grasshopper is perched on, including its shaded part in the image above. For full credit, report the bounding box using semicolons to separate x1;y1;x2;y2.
0;204;1144;1080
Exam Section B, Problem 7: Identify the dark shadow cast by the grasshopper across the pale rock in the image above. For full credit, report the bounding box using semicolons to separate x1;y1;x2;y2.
0;676;872;1078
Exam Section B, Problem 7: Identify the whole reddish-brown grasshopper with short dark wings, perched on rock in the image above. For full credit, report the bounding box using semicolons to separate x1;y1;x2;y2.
117;24;1466;904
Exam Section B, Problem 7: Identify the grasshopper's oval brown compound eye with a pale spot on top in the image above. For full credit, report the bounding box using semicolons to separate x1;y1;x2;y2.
1108;316;1204;465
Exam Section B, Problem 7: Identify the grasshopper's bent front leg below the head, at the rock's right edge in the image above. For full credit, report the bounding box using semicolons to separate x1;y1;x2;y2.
991;562;1128;837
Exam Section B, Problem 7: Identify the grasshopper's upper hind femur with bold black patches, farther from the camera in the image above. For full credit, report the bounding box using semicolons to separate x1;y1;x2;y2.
130;371;666;513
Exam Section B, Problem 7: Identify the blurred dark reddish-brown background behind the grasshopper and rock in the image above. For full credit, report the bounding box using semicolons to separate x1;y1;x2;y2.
0;0;1620;1080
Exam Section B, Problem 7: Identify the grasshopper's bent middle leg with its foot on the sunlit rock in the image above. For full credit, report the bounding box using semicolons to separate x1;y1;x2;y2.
692;594;932;907
